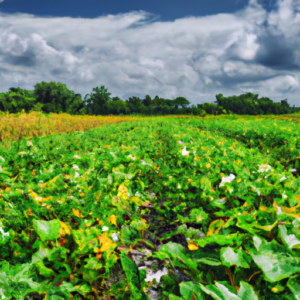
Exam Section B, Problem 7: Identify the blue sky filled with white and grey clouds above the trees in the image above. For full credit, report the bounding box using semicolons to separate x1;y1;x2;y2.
0;0;300;106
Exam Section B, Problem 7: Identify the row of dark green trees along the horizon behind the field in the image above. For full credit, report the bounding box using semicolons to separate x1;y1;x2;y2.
0;81;300;116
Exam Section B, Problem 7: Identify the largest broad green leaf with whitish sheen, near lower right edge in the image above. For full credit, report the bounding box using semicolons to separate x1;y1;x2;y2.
250;240;300;282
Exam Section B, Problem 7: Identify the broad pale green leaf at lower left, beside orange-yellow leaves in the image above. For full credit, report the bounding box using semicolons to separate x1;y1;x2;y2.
33;220;61;241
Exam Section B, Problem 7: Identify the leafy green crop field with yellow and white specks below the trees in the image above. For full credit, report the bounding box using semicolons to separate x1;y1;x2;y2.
0;116;300;300
